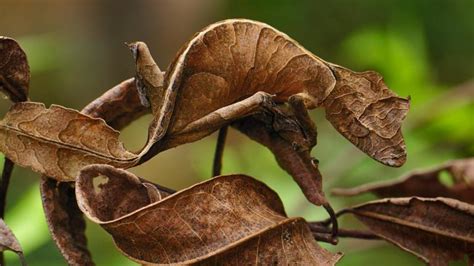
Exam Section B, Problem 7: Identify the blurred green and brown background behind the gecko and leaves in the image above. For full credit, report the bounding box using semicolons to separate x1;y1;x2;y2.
0;0;474;265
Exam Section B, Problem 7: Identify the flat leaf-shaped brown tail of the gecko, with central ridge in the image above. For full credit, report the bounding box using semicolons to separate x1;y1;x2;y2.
0;102;137;181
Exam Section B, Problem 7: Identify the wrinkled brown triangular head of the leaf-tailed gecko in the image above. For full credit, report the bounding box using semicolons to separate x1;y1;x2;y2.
323;66;410;167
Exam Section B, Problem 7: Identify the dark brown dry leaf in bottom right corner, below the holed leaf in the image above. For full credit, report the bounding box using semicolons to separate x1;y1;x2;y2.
346;197;474;265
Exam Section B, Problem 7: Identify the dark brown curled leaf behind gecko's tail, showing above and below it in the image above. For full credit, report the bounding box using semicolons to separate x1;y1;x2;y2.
40;79;148;265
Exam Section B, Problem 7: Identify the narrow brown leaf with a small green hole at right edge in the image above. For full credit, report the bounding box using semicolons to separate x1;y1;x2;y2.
332;158;474;204
